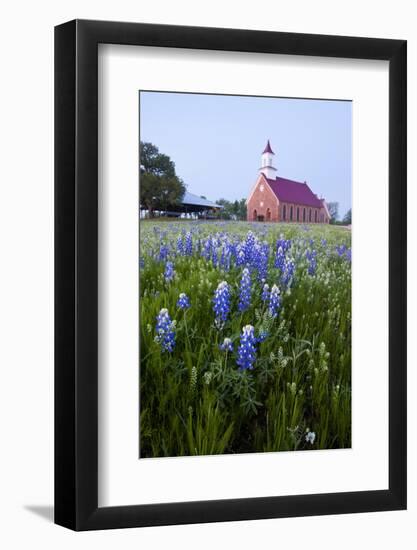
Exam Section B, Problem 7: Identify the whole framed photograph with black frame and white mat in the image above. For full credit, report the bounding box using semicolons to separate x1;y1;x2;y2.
55;20;406;530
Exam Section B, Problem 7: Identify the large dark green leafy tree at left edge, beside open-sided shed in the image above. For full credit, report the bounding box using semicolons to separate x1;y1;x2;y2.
139;141;185;217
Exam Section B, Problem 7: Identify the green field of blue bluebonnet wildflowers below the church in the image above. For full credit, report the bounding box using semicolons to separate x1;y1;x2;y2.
139;220;351;457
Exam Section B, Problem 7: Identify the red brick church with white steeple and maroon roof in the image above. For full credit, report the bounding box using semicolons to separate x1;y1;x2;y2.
246;140;330;223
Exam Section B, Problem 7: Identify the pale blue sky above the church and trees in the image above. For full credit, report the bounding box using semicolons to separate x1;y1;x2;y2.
140;92;352;217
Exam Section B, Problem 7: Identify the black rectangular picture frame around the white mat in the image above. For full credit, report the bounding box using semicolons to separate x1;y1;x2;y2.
55;20;407;531
